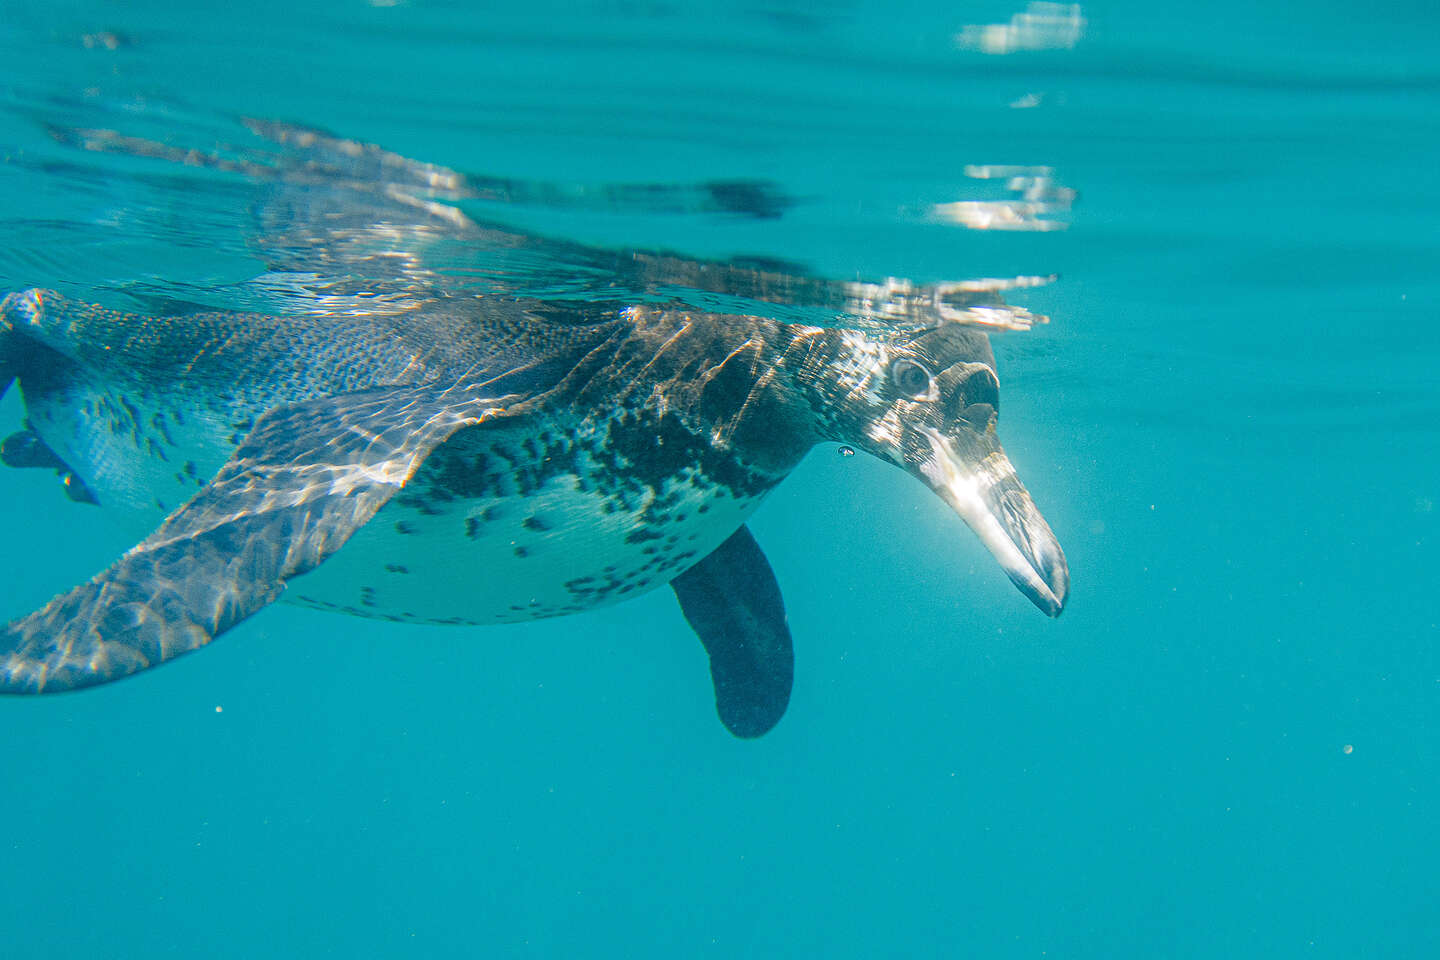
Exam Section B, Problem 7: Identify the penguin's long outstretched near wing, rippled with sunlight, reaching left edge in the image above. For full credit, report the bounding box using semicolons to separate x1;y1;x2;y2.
0;386;520;694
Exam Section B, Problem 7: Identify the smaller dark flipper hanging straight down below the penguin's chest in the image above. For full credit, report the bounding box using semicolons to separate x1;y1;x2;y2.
670;527;795;738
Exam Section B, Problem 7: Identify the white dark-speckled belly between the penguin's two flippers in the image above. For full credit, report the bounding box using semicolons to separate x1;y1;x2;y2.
285;434;762;623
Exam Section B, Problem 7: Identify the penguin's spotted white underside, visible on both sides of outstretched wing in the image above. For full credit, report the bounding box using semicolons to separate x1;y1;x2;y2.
22;384;778;623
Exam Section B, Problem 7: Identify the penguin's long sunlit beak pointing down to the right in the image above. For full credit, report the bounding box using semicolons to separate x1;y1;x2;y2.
912;426;1070;616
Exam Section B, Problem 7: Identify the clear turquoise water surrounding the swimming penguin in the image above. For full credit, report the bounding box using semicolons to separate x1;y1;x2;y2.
0;0;1440;960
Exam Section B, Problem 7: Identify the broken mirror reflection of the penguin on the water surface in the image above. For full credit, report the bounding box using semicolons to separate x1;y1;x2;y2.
49;119;1073;331
